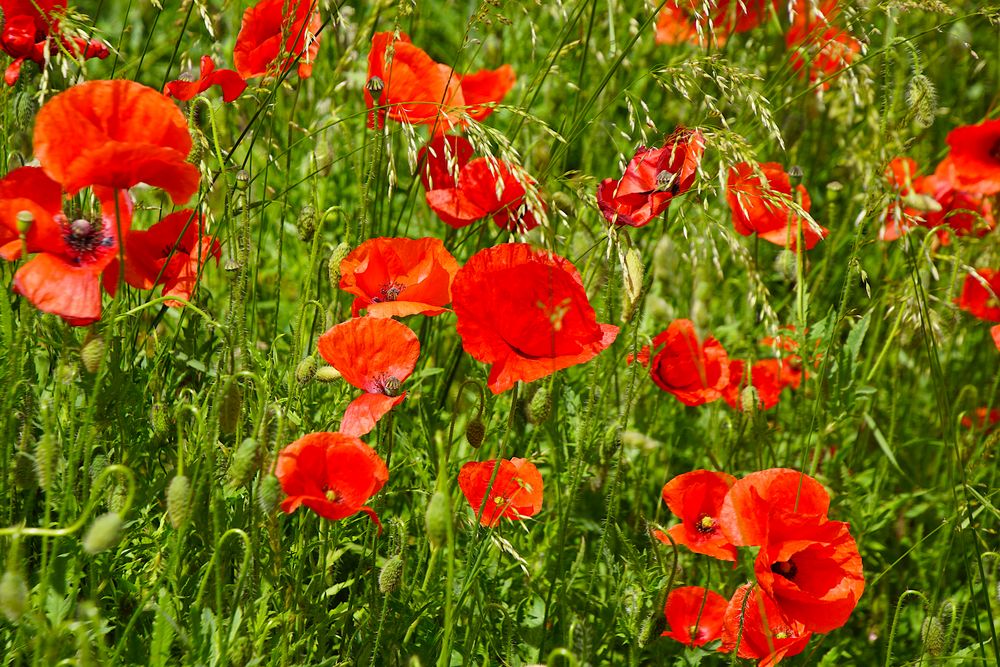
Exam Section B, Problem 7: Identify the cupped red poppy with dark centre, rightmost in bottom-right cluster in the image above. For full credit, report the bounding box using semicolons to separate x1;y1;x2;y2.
754;513;865;632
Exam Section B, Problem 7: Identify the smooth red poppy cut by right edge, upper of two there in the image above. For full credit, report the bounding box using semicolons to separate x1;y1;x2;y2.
938;119;1000;195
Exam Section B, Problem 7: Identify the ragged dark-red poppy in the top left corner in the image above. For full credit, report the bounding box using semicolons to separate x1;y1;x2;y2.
0;0;108;86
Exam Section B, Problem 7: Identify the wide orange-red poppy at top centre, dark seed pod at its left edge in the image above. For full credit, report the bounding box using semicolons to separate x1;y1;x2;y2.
365;32;516;134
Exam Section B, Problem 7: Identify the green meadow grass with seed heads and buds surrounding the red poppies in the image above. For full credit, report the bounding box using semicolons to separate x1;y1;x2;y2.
0;0;1000;666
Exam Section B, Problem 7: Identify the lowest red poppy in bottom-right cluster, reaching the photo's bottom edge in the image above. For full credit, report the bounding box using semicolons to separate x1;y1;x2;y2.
720;584;812;667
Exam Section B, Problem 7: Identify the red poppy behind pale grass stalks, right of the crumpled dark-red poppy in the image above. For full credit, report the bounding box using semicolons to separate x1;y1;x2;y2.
726;162;830;250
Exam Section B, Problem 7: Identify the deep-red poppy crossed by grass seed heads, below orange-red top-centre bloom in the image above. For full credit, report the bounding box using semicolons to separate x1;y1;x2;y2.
418;135;538;232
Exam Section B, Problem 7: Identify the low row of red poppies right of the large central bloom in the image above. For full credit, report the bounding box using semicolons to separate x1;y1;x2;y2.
627;319;804;410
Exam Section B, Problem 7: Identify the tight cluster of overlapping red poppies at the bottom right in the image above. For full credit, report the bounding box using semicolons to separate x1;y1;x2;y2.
654;468;865;665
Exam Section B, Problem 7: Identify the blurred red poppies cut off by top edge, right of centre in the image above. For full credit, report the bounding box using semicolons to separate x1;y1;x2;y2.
656;0;861;88
